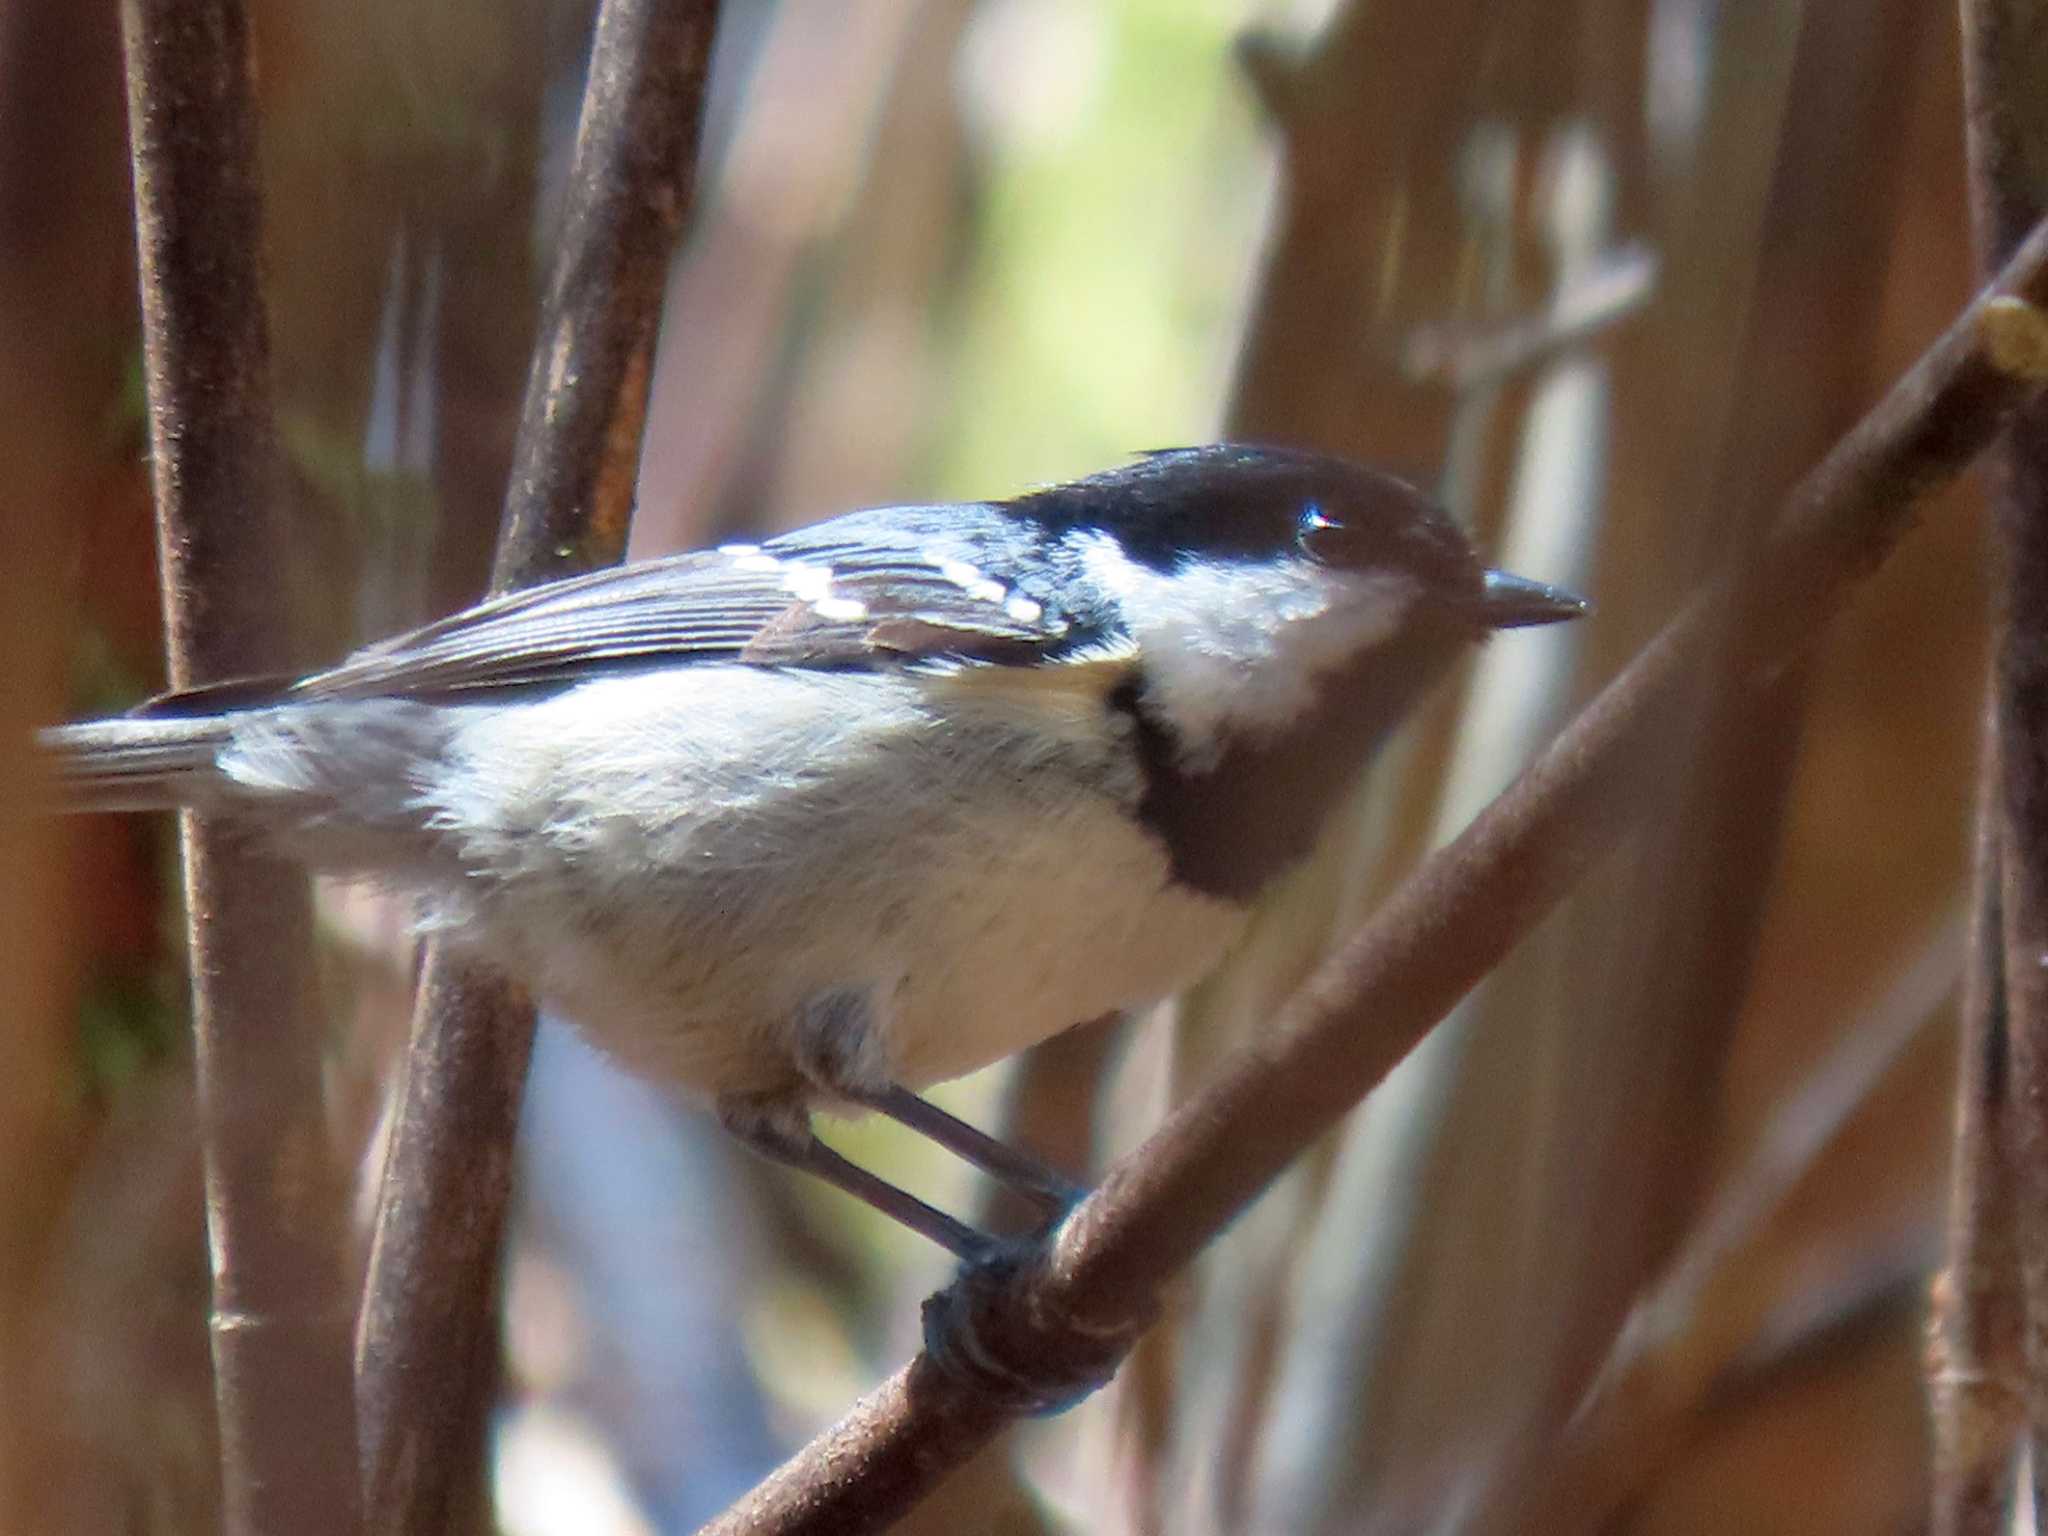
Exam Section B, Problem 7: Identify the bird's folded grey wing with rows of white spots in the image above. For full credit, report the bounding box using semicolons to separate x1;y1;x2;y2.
289;508;1075;698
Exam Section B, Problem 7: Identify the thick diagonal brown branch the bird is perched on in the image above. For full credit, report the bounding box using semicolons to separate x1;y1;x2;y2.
709;225;2048;1536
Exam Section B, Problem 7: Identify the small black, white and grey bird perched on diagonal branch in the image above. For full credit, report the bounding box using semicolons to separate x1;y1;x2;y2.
41;444;1585;1253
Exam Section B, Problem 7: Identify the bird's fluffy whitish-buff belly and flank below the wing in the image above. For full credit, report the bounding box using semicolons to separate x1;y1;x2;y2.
417;666;1243;1096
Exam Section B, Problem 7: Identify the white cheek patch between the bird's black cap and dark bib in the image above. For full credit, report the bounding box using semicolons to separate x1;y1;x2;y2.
1085;537;1417;768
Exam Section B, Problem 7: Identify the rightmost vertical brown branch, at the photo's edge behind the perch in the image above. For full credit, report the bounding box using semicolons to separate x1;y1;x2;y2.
1962;0;2048;1518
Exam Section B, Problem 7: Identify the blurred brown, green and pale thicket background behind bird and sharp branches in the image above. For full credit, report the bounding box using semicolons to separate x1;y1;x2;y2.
0;0;1987;1536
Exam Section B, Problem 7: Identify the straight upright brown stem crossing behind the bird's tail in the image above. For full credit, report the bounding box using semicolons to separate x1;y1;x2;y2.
121;0;356;1532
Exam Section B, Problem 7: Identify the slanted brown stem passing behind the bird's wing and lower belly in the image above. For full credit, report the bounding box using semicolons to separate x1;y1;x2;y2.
356;0;719;1532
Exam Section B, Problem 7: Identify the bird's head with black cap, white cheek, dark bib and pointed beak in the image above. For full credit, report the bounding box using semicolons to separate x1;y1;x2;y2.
1012;444;1585;897
